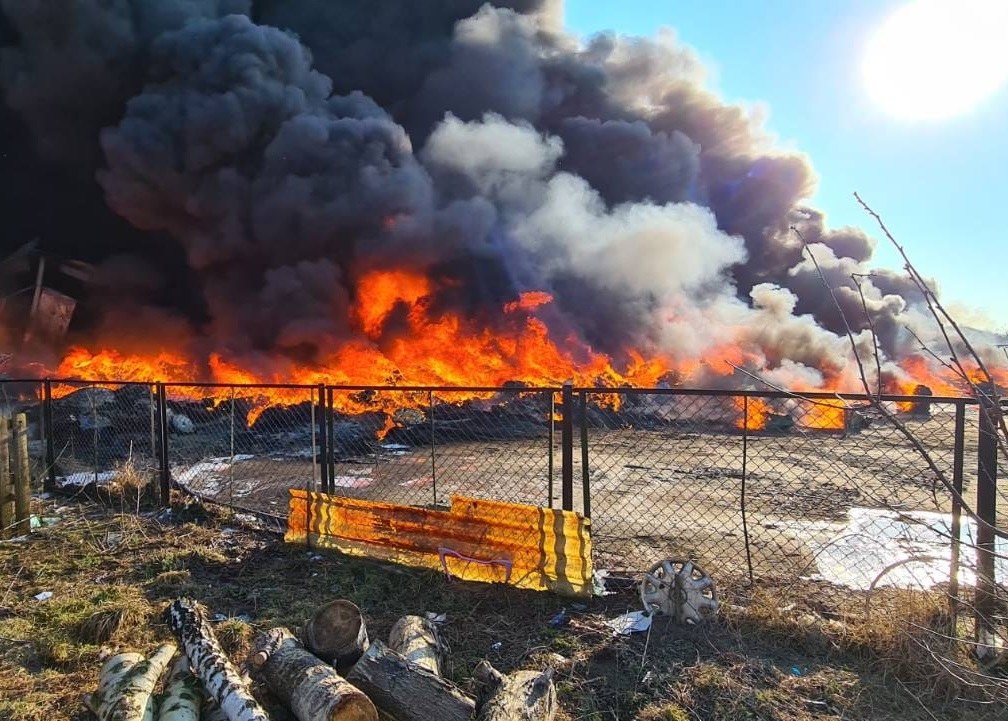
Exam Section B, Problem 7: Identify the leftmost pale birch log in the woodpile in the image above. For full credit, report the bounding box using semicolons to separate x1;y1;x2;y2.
85;643;175;721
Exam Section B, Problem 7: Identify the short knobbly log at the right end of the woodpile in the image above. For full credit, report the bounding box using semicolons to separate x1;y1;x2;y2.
473;660;556;721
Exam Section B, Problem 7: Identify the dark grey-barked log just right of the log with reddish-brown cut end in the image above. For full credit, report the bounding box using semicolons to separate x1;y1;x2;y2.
347;641;476;721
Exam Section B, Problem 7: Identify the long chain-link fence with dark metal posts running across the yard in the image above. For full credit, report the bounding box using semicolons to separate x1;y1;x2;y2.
0;379;1008;633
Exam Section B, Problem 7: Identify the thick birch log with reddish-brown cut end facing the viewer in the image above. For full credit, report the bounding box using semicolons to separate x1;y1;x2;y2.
248;628;378;721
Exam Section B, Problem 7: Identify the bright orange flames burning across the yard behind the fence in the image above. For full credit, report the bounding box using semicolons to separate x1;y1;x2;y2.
11;269;1008;431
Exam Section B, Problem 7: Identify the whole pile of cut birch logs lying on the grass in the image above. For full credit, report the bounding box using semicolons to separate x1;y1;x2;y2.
86;598;556;721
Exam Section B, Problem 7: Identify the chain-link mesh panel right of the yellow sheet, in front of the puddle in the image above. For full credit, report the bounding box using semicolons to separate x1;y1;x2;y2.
579;391;976;590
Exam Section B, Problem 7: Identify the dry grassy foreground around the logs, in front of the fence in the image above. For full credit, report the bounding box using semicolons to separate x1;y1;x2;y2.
0;496;1004;721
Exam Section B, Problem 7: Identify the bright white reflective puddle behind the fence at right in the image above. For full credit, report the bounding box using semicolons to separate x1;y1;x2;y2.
794;508;1008;591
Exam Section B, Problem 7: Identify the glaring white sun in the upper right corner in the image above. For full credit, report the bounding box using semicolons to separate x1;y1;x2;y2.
863;0;1008;120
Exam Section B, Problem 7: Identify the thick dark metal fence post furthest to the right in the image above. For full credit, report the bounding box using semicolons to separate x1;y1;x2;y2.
975;384;1001;657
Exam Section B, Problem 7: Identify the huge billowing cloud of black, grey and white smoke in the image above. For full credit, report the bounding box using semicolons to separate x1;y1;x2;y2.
0;0;991;385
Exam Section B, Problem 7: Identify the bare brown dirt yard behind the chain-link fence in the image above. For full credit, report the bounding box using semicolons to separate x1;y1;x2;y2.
161;407;995;601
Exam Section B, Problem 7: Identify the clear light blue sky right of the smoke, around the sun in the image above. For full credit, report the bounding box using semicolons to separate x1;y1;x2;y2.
565;0;1008;331
